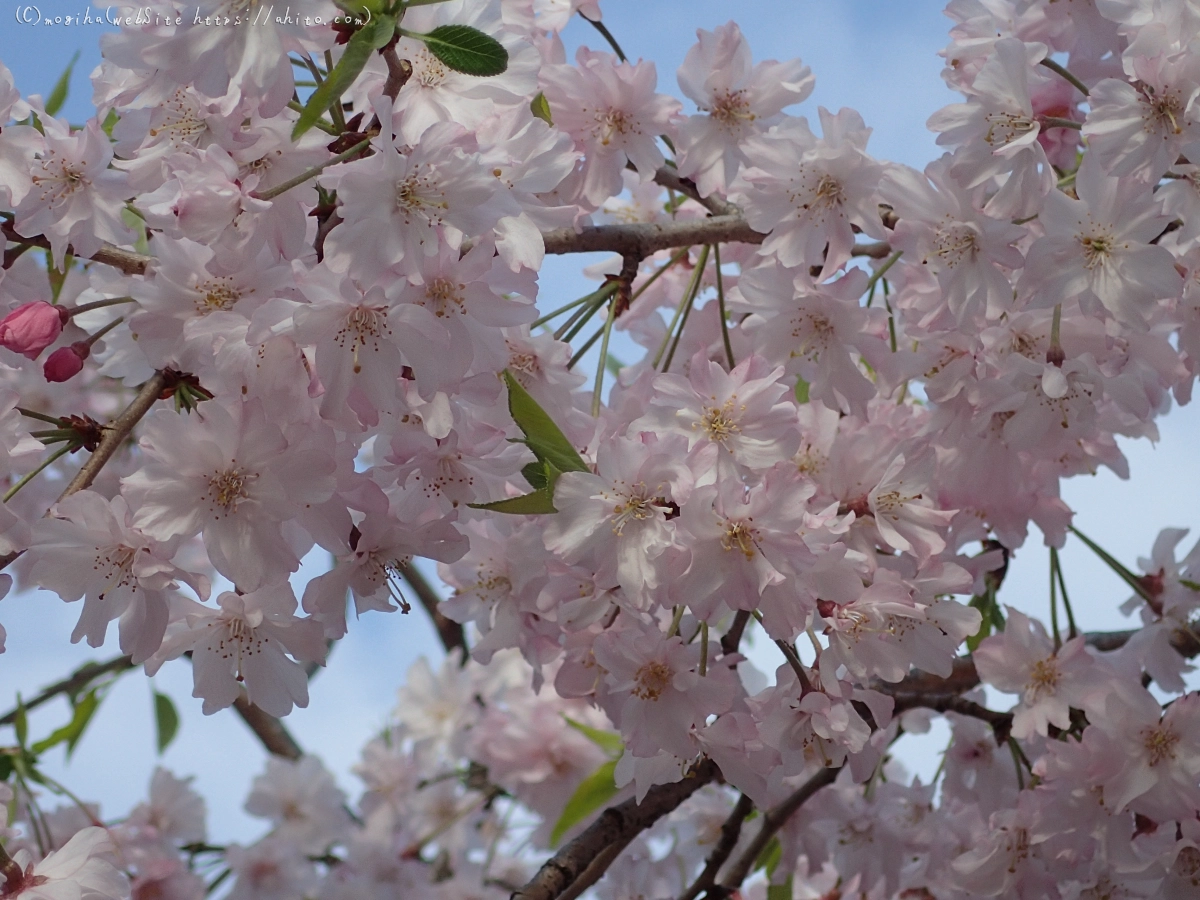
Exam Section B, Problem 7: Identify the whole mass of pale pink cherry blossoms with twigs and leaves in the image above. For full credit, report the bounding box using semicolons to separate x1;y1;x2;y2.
0;0;1200;900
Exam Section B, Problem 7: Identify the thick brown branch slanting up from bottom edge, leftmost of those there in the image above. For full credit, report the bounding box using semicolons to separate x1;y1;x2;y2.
511;760;720;900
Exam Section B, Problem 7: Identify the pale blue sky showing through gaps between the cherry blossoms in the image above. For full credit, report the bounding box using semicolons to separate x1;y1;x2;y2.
7;0;1200;842
